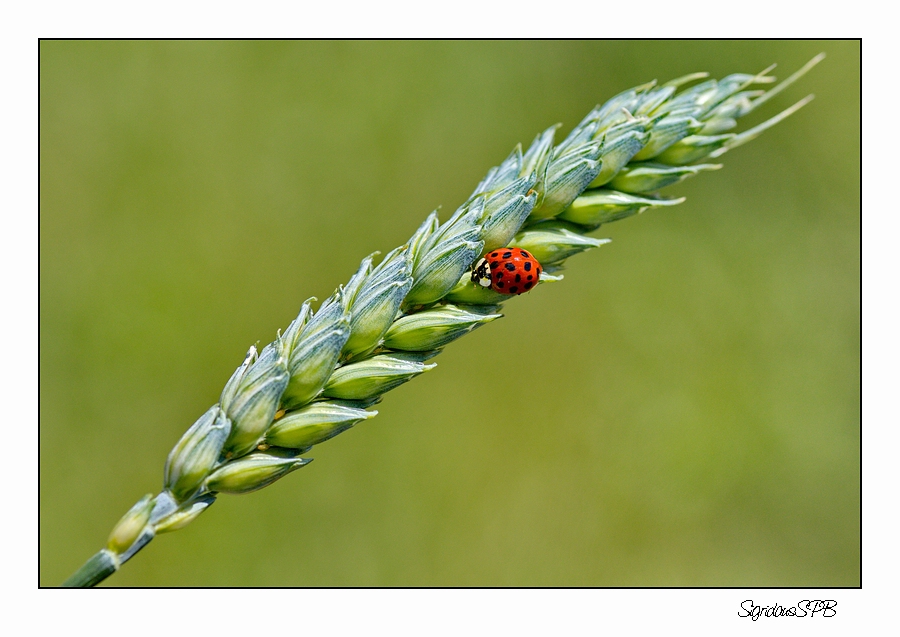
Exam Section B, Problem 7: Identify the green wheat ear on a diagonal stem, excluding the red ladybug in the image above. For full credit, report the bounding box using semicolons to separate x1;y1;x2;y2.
63;54;825;586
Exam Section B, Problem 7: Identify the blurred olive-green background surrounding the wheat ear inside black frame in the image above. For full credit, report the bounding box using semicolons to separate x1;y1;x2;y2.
40;41;860;586
